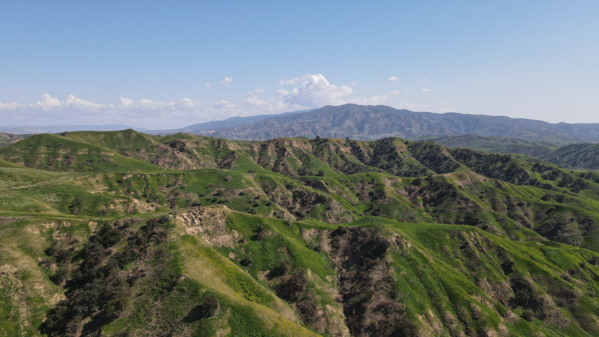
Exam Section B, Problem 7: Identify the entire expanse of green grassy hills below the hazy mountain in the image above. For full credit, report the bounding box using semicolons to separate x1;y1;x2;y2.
0;131;599;336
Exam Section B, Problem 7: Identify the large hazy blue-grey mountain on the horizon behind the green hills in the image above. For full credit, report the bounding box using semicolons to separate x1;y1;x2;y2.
195;104;599;145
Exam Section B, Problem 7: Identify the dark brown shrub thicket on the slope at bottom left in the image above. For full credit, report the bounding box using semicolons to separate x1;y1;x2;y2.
40;218;168;336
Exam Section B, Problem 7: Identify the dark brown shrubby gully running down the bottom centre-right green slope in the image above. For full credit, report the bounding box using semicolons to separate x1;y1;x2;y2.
329;227;418;336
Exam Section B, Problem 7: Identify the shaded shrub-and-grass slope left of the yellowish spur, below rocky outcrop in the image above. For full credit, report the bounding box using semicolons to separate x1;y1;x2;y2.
40;217;232;336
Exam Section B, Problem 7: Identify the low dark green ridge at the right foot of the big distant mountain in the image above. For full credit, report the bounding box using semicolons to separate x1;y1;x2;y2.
420;134;559;158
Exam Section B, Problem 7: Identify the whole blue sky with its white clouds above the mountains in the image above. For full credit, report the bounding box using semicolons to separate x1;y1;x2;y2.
0;0;599;129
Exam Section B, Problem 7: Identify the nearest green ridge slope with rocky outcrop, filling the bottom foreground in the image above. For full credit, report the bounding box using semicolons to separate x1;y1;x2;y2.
0;207;599;336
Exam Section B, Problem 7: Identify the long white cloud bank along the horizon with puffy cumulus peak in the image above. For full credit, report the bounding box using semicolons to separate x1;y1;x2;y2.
0;74;424;130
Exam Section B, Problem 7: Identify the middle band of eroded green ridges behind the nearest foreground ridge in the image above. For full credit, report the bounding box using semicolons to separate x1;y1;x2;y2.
6;131;599;250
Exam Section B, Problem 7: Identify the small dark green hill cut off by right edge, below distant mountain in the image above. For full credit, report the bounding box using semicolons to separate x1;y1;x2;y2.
541;144;599;170
